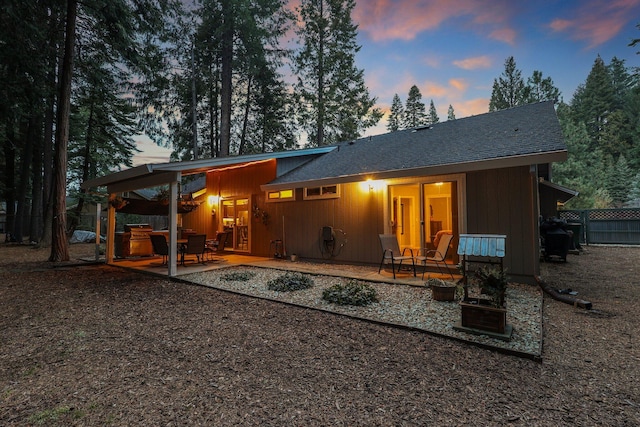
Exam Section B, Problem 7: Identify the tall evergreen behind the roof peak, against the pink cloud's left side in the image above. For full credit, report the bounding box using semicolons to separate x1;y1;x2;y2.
294;0;382;146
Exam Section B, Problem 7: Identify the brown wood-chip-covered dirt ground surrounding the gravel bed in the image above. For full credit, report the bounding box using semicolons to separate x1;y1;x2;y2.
0;245;640;426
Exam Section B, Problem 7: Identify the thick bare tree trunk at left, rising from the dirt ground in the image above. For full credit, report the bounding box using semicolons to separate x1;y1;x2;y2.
49;0;78;262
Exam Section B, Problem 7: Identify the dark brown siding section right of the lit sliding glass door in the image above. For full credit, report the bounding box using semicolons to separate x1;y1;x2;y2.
466;167;539;278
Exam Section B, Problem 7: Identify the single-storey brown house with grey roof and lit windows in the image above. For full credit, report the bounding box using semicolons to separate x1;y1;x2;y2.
83;102;567;282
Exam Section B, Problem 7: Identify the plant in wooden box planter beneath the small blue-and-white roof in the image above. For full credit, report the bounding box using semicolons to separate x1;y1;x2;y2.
460;266;511;339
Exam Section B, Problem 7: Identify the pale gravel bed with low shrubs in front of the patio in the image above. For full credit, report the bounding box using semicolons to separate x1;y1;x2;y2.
181;267;542;357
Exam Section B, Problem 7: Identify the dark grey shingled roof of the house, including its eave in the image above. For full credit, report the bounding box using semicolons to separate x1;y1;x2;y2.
262;101;567;190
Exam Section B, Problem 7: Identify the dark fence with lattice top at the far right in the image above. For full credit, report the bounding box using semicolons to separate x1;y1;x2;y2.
558;208;640;245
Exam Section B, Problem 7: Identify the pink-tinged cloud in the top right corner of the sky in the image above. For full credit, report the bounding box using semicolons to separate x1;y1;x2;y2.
549;0;640;48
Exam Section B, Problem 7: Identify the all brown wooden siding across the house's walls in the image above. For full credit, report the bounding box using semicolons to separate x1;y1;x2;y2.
182;160;539;278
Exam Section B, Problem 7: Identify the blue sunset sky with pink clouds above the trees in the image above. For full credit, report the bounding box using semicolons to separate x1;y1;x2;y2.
134;0;640;165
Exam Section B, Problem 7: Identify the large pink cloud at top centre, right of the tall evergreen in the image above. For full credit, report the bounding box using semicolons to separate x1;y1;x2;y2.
353;0;515;41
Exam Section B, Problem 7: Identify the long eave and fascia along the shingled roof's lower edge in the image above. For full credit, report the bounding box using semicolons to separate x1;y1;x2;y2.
260;150;567;191
